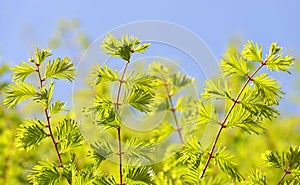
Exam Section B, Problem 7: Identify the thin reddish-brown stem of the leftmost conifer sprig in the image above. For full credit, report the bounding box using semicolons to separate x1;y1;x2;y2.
35;64;72;184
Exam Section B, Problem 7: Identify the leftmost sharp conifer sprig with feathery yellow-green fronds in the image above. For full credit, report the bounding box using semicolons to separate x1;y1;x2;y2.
3;49;77;184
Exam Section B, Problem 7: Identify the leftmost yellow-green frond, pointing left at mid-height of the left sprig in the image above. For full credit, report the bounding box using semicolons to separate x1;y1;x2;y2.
3;82;37;108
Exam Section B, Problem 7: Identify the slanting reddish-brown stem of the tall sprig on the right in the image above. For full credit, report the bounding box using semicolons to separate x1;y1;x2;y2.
200;61;267;180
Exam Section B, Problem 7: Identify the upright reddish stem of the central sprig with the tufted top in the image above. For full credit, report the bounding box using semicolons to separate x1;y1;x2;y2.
115;60;130;185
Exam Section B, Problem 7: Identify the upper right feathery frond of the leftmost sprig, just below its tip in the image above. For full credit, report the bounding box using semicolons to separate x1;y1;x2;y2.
45;57;75;81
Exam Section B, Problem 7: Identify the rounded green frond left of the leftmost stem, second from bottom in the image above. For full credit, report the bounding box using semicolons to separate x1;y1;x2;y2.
16;119;47;151
